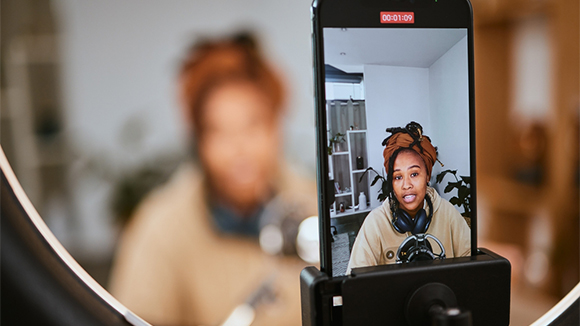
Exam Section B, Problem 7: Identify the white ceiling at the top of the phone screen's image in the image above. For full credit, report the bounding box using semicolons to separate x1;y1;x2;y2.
324;28;467;73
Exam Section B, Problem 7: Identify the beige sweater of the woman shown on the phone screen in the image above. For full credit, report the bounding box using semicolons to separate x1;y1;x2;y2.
346;187;471;274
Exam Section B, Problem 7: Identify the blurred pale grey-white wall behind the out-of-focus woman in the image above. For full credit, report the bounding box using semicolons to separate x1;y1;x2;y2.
56;0;315;168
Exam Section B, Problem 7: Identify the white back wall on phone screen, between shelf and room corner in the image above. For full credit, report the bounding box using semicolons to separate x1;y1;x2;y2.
364;65;431;207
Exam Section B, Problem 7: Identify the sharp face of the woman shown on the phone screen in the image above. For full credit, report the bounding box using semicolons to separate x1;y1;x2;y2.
393;150;427;218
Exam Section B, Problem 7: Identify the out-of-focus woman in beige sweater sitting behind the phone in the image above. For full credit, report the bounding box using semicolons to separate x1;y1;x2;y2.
111;35;316;325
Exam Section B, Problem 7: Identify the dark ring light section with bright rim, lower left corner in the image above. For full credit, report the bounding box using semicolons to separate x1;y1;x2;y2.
0;147;148;326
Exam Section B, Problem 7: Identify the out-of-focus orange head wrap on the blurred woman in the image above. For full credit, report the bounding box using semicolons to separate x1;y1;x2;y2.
179;33;285;134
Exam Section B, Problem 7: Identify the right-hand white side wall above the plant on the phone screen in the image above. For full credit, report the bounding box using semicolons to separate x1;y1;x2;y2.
426;36;471;199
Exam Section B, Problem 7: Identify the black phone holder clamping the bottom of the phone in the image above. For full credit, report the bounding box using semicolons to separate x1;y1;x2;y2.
300;249;511;326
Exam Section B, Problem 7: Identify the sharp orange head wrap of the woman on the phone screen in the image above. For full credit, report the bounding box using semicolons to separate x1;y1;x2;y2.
383;121;437;180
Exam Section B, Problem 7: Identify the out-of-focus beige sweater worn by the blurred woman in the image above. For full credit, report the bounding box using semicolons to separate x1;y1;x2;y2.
110;165;316;325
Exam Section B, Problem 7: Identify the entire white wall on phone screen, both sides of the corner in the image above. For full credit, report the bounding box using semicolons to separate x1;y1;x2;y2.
364;37;470;207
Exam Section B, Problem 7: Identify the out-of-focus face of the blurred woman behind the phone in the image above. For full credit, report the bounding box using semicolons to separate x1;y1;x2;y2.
198;82;279;212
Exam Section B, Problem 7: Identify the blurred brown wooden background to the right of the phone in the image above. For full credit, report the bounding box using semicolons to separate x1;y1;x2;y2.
472;0;580;325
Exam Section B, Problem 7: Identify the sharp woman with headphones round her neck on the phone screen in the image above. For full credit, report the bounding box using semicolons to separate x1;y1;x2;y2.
347;122;471;274
